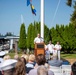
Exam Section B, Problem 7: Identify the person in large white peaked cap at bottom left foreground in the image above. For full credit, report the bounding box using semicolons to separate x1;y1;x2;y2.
0;59;17;75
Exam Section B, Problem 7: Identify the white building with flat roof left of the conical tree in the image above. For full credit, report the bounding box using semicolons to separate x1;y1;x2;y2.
0;36;19;50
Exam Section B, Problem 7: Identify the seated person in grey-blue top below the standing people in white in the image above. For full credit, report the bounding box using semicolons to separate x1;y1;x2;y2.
48;55;63;67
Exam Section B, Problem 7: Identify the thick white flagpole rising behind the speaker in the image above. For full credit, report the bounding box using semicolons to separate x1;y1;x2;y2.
41;0;44;38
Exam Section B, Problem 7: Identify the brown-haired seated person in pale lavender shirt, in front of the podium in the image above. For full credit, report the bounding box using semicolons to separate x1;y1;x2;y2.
28;54;54;75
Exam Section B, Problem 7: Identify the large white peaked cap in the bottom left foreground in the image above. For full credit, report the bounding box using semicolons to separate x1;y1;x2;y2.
0;59;17;70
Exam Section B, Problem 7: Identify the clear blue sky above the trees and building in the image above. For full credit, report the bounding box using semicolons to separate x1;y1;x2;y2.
0;0;73;35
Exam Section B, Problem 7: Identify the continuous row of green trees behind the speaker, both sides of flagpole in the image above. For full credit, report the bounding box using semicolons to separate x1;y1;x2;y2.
27;22;76;53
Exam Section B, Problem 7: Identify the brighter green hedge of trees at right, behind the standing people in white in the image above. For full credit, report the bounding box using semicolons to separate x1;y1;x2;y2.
50;24;76;53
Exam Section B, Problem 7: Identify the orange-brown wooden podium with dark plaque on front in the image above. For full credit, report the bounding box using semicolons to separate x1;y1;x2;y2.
34;43;45;56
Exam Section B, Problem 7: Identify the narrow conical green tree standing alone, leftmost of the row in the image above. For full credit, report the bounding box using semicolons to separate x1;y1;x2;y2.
18;23;27;50
